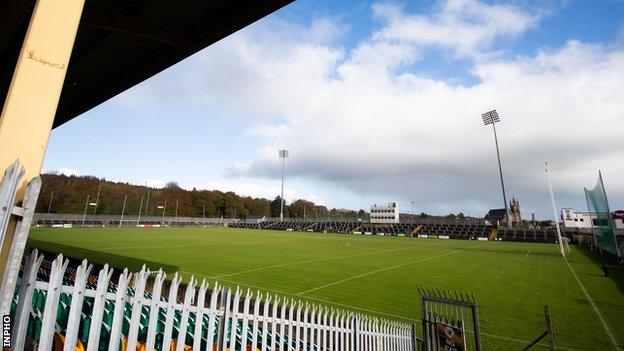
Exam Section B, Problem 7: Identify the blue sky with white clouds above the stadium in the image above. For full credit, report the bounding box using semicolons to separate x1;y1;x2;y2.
44;0;624;218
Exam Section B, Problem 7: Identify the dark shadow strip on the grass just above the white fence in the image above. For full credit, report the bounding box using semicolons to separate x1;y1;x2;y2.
26;239;179;275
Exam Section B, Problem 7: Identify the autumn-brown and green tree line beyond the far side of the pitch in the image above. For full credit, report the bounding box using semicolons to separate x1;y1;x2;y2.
36;173;366;219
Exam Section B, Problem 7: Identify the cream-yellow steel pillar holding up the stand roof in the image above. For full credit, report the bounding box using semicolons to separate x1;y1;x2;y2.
0;0;84;275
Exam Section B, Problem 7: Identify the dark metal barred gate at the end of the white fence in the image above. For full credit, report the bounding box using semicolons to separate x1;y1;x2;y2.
418;287;481;351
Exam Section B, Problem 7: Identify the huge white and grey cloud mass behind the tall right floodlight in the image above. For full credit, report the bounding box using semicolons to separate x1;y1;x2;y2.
113;0;624;217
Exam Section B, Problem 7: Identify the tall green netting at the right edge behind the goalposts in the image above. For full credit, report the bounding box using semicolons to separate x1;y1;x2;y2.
585;175;618;256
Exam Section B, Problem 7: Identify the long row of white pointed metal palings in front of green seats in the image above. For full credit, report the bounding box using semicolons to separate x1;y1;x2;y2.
12;250;415;351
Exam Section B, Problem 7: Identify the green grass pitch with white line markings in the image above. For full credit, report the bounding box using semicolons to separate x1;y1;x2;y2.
29;228;624;350
